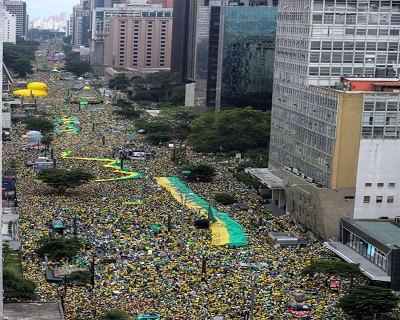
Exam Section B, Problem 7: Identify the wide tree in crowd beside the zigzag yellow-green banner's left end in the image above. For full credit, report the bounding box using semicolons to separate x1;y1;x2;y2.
36;168;94;193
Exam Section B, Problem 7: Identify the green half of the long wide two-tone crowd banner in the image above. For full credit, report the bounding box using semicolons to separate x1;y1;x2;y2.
167;177;248;246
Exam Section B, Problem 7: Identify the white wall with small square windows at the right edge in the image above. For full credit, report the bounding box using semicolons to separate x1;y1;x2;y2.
354;139;400;219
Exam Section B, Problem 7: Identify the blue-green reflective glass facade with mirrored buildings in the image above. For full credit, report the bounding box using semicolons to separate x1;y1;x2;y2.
221;6;277;110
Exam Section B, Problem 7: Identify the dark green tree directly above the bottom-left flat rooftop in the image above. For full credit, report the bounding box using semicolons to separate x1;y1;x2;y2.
3;268;36;302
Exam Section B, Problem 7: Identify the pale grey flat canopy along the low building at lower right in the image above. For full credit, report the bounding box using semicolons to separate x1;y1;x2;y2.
323;241;392;282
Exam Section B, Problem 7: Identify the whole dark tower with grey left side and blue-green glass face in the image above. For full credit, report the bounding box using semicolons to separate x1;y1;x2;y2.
194;0;277;111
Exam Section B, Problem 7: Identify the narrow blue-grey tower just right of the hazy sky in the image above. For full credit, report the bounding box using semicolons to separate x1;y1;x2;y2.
72;0;90;47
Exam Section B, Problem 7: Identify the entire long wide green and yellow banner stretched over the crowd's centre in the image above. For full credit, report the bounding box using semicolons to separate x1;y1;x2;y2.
157;177;247;246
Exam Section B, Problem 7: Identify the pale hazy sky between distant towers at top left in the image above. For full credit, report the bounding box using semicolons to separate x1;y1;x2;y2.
23;0;79;20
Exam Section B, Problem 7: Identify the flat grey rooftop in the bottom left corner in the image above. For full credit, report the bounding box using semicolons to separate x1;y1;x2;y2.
4;302;64;320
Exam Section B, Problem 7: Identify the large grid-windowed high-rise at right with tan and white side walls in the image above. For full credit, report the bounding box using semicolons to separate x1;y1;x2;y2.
265;0;400;239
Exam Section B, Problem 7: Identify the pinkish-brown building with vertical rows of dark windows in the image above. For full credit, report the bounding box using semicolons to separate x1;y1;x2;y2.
104;17;172;71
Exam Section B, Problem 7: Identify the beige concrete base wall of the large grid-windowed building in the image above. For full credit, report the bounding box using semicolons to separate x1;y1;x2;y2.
279;170;355;240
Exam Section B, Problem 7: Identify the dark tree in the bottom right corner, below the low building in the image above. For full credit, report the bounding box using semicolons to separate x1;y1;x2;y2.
337;286;399;320
